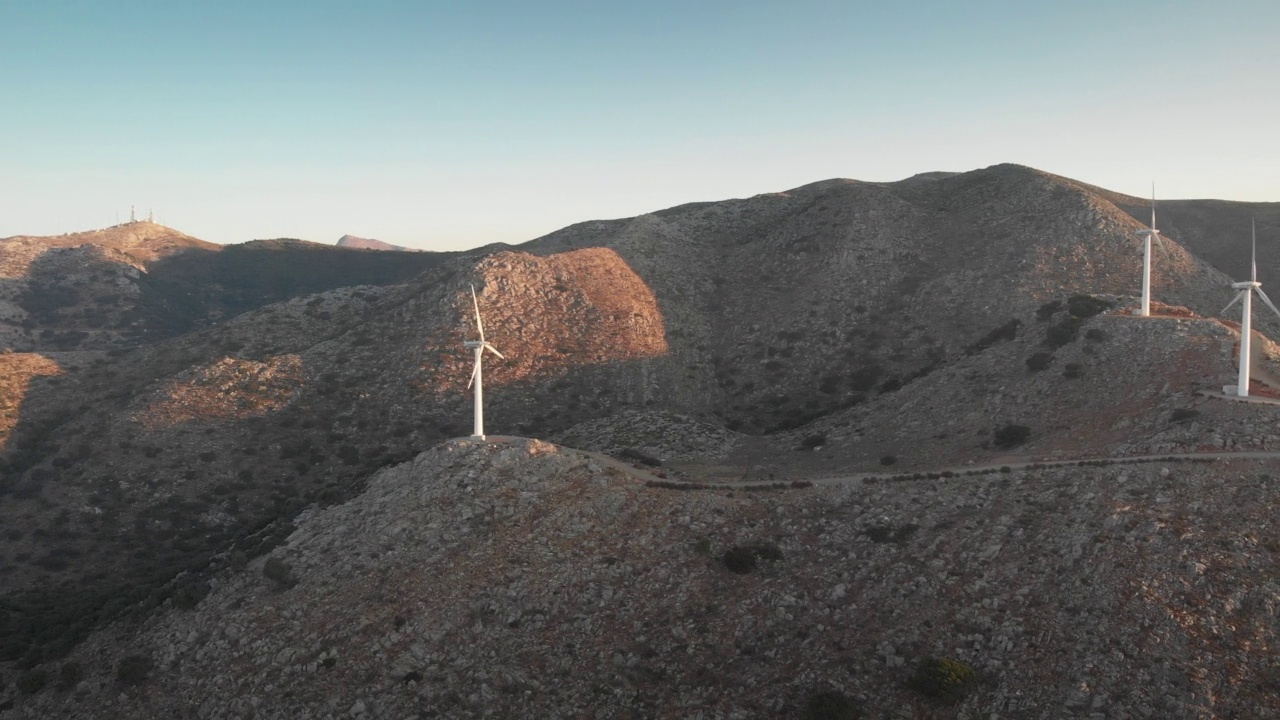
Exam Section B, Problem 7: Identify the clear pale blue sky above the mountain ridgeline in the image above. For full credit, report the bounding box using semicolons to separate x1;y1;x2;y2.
0;0;1280;250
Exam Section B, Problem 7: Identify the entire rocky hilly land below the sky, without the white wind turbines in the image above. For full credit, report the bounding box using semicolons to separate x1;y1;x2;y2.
0;165;1280;720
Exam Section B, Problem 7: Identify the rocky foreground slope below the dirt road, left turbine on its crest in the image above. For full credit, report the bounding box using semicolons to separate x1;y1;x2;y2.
10;441;1280;719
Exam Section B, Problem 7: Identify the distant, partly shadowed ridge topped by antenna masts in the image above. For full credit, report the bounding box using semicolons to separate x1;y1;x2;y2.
0;222;451;351
